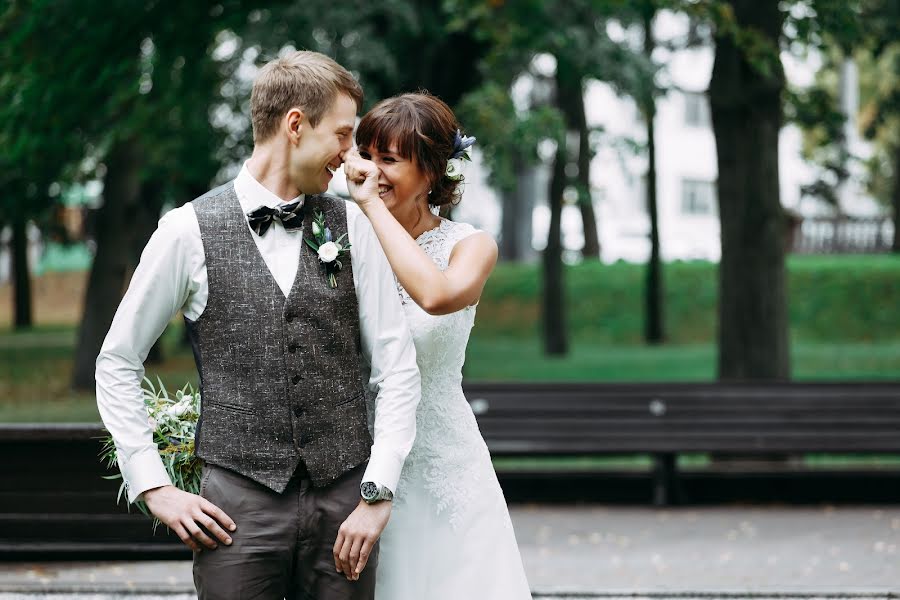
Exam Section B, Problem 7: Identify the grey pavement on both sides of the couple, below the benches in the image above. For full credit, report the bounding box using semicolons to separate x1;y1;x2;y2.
0;505;900;600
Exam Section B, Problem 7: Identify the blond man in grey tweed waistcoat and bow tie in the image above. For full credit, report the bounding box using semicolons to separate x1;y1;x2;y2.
96;52;420;600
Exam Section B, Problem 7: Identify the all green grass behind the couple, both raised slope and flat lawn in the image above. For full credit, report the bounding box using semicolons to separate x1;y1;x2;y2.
0;255;900;422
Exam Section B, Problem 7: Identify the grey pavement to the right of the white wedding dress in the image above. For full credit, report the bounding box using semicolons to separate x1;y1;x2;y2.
515;507;900;592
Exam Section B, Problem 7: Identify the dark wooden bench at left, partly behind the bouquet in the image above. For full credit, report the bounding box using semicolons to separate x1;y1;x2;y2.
0;423;190;560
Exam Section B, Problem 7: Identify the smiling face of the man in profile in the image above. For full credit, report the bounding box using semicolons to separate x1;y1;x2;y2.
288;94;356;194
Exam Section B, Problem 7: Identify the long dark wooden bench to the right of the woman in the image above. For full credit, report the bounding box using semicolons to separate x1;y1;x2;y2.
466;383;900;505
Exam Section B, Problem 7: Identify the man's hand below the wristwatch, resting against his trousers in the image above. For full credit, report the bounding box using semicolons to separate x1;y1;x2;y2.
334;500;391;581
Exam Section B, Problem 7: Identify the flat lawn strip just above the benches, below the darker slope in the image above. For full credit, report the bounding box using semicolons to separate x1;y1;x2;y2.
0;326;900;422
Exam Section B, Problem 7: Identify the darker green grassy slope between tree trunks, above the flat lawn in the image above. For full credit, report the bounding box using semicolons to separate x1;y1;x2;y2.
479;255;900;345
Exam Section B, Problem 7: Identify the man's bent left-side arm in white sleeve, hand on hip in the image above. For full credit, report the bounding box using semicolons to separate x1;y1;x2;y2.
96;205;237;551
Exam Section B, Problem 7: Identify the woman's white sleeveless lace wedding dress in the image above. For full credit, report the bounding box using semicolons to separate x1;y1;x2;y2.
375;219;531;600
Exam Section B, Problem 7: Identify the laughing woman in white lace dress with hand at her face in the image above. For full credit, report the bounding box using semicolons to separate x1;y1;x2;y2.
335;93;531;600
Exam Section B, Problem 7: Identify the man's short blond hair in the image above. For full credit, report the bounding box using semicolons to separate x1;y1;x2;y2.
250;50;363;144
